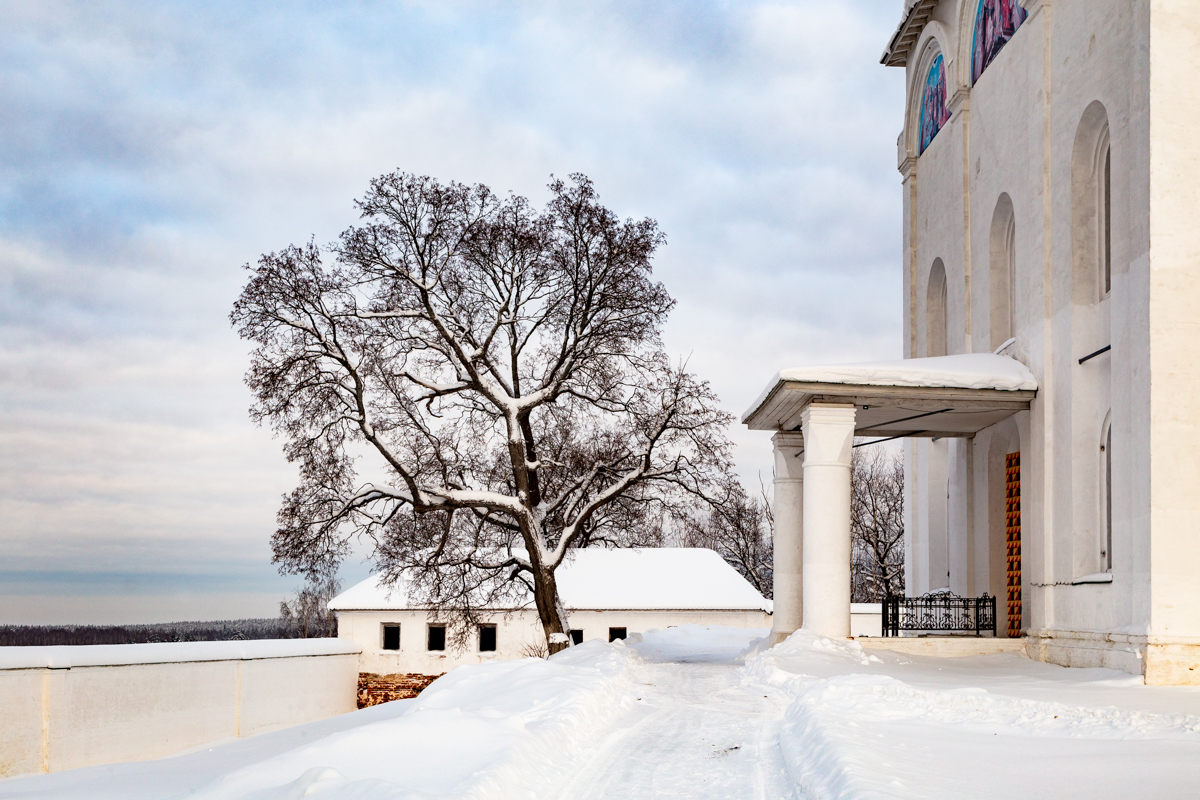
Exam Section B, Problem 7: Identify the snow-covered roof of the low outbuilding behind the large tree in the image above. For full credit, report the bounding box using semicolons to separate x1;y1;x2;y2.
329;547;770;610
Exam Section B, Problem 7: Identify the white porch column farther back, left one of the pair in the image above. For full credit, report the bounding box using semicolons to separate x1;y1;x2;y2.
770;431;804;643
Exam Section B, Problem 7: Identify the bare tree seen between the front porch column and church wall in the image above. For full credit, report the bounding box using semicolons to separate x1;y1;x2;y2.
850;447;904;602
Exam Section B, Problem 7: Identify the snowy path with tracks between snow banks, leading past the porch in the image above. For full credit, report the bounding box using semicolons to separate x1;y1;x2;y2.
547;662;793;800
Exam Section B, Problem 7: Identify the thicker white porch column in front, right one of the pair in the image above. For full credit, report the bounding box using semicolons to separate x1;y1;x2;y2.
800;403;854;638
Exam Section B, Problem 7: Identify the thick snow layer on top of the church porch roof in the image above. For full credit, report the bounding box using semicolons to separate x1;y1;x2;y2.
742;353;1038;422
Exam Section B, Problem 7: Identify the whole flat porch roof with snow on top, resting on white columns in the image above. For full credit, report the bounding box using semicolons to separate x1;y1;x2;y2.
742;353;1038;437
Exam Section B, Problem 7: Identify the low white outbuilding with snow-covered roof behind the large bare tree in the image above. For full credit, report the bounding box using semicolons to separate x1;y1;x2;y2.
329;548;770;675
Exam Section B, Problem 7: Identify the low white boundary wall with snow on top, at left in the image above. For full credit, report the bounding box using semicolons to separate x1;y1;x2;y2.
0;639;360;777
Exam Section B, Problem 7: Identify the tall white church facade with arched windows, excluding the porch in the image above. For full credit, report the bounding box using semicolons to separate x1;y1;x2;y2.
886;0;1200;684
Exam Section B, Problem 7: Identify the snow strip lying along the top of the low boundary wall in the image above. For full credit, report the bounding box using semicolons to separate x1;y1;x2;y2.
0;639;362;669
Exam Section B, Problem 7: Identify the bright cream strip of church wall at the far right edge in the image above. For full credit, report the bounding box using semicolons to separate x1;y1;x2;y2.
1148;0;1200;652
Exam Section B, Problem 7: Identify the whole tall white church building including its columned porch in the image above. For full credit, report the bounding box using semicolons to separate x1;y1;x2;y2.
743;0;1200;684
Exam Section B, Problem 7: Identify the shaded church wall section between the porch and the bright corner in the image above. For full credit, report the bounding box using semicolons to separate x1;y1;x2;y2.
1045;0;1148;631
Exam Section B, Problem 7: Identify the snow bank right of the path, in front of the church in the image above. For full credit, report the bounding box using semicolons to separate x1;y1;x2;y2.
745;631;1200;799
